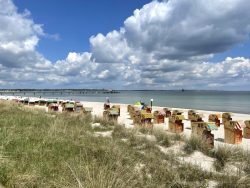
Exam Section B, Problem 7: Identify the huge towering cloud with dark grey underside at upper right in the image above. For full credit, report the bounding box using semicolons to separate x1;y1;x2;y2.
90;0;250;62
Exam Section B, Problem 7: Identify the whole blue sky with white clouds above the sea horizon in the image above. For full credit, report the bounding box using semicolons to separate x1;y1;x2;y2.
0;0;250;91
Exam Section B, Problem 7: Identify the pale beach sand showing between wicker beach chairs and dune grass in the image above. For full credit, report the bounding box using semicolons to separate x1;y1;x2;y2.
0;98;250;187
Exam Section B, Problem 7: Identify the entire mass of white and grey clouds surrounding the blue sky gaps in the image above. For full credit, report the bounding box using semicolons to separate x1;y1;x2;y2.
0;0;250;89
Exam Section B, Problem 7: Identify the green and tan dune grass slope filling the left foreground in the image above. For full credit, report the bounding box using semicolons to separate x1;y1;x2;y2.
0;101;248;188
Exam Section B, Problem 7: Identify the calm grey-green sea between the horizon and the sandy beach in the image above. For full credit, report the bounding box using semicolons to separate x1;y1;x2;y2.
3;91;250;114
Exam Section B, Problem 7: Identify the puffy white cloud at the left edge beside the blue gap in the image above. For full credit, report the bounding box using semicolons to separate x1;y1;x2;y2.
0;0;44;67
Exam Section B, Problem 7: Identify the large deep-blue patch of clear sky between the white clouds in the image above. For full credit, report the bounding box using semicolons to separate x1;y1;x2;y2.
14;0;151;61
